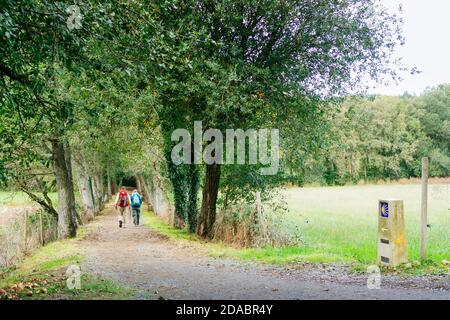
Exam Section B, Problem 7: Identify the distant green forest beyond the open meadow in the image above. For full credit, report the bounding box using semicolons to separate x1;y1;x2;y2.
286;85;450;185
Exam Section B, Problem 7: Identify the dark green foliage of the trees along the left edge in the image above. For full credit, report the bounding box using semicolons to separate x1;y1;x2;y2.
0;0;129;222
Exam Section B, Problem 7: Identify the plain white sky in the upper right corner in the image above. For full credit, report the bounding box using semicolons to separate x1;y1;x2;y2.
370;0;450;95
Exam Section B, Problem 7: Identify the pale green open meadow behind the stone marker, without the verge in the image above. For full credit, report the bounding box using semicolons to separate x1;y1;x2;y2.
285;184;450;263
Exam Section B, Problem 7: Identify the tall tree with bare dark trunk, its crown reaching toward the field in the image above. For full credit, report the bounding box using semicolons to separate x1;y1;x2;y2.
188;0;403;236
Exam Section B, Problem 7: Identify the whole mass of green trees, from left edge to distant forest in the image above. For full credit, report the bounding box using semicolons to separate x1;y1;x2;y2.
0;0;450;242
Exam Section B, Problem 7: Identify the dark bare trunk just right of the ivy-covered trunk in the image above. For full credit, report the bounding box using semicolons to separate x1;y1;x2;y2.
197;164;220;237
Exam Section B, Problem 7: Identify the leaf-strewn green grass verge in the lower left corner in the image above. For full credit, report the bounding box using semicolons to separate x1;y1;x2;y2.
0;221;134;299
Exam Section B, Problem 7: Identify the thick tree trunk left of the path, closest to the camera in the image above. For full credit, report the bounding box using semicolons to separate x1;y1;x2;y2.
51;140;76;239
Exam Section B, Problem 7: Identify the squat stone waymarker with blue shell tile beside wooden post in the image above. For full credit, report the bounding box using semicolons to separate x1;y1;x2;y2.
377;199;408;267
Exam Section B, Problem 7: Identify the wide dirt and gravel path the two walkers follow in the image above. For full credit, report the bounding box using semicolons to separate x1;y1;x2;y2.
80;208;450;299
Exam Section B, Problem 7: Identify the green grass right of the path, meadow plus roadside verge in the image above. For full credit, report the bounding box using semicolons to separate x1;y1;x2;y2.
145;185;450;274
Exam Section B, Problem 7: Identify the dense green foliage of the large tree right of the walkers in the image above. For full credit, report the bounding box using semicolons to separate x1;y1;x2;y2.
149;0;402;232
